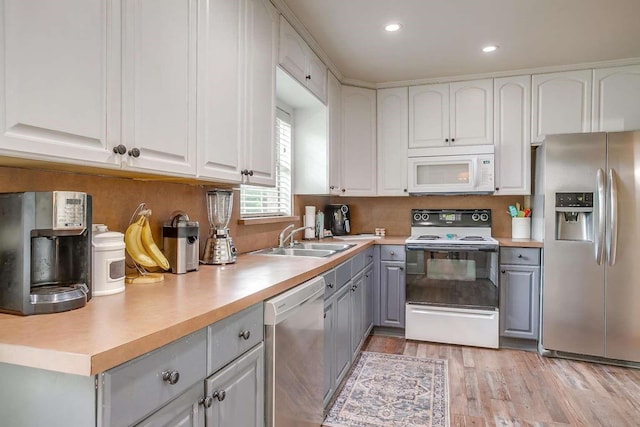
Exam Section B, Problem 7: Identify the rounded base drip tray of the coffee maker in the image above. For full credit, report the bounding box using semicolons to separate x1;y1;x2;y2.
29;283;89;314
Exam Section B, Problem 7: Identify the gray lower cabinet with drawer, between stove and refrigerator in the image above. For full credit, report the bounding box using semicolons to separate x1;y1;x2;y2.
500;248;540;343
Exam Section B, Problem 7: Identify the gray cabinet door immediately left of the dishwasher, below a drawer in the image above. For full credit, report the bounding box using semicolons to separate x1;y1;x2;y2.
205;343;264;427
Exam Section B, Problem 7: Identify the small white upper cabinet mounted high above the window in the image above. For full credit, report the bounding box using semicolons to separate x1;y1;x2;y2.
279;16;327;103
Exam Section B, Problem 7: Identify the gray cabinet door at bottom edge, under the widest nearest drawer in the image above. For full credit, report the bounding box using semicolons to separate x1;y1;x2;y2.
138;382;204;427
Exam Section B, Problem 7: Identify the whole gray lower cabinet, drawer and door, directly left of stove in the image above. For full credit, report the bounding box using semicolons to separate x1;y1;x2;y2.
375;245;406;328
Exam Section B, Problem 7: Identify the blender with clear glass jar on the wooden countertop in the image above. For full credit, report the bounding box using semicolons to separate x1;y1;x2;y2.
202;190;236;264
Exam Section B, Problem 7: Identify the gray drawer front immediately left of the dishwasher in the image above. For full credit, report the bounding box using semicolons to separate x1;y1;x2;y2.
207;303;264;375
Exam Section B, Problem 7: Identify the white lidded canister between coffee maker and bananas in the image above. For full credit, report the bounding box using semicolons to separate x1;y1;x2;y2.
91;224;125;296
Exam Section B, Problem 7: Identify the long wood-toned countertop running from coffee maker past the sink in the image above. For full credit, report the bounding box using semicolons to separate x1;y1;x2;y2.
0;239;376;376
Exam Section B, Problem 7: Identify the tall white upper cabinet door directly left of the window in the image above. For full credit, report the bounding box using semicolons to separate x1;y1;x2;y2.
243;0;278;186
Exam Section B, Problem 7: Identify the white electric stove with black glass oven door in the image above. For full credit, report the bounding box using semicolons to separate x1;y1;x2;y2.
405;209;499;348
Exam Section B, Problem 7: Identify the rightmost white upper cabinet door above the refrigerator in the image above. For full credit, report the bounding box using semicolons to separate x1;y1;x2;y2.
593;65;640;132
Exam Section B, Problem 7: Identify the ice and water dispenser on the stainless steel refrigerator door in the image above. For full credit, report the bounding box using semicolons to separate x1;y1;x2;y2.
556;193;593;241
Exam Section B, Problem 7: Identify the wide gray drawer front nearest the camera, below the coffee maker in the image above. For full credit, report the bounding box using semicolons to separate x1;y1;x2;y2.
101;329;207;426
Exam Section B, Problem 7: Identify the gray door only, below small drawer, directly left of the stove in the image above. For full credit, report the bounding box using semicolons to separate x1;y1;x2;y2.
380;261;406;328
